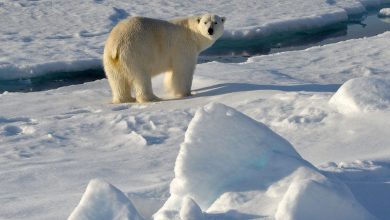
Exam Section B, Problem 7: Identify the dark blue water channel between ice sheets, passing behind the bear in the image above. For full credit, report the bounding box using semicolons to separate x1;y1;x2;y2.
0;9;390;93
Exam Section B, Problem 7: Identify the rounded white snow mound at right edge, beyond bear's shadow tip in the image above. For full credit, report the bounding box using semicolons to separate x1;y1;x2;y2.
329;77;390;114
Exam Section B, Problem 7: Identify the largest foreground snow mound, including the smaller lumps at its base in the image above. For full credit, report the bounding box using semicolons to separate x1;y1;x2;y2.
154;103;373;220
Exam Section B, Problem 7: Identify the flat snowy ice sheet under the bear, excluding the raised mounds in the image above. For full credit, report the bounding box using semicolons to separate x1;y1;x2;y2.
0;29;390;220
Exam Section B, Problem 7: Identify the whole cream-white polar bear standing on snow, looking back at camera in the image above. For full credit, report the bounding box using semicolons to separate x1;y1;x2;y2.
103;14;226;103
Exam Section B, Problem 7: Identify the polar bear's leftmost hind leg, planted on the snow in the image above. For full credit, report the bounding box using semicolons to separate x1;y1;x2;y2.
107;73;135;104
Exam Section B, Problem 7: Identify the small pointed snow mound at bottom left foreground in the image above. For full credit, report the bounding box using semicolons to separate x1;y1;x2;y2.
68;179;143;220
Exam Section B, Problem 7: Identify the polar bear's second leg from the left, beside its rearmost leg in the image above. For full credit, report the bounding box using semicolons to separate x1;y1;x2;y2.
133;74;161;103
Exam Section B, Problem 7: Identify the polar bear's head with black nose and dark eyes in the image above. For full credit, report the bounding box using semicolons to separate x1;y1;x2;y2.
197;14;226;41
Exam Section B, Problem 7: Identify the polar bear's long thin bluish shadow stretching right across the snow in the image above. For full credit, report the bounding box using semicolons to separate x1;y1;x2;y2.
192;83;341;97
